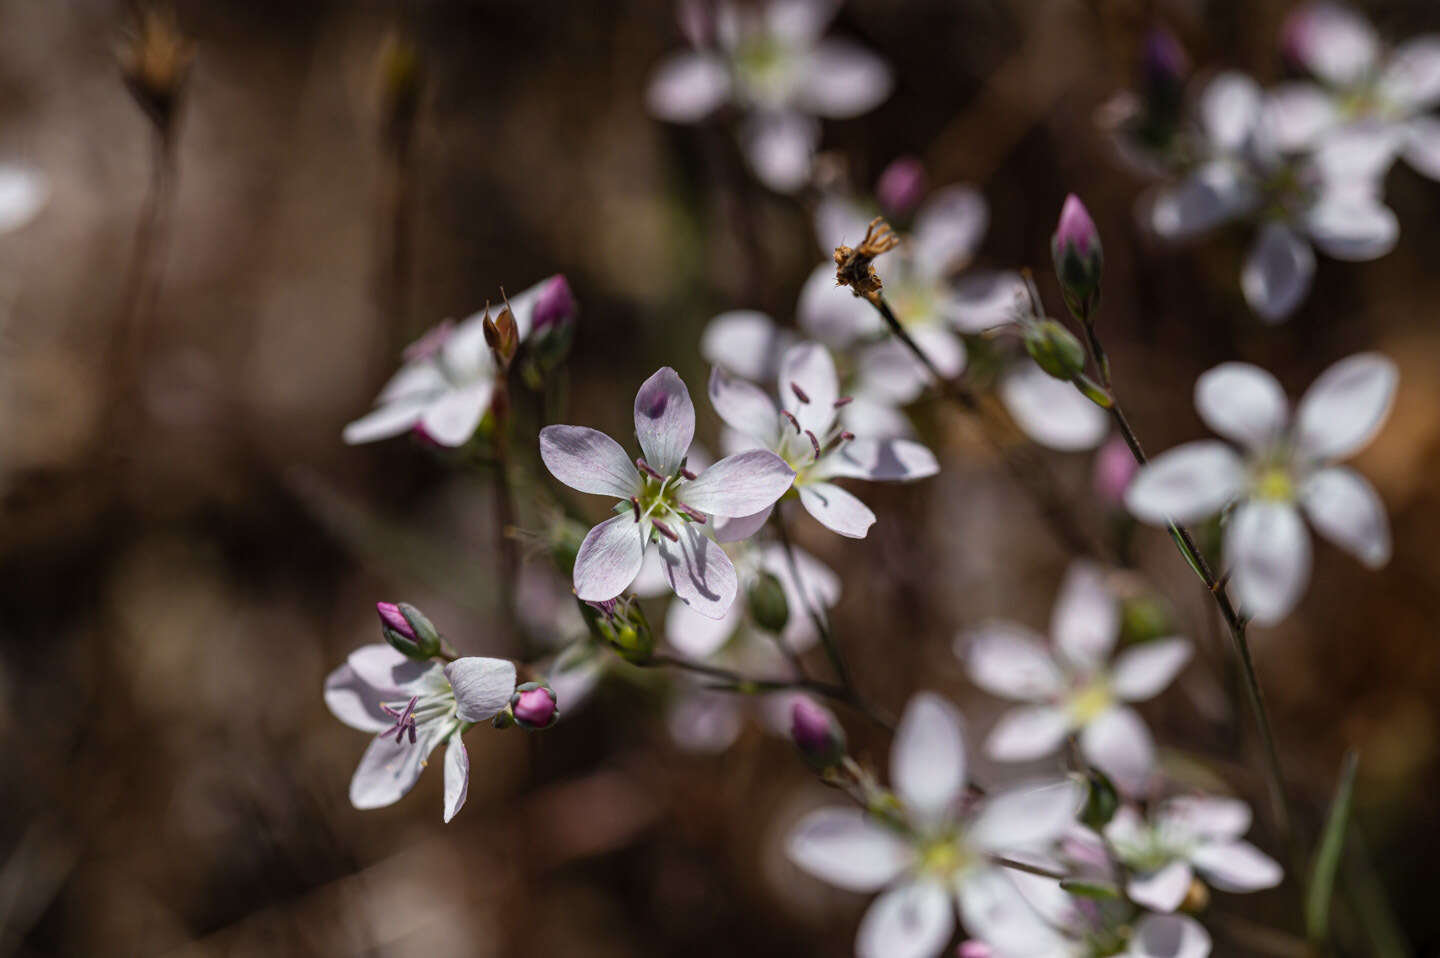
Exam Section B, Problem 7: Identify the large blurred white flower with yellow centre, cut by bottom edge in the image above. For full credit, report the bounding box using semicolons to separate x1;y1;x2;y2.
786;693;1083;958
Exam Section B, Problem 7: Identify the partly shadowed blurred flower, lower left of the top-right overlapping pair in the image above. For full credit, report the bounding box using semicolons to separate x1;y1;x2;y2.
1145;72;1400;323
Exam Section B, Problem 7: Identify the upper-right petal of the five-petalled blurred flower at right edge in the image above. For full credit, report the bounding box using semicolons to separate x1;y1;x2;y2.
1295;353;1400;461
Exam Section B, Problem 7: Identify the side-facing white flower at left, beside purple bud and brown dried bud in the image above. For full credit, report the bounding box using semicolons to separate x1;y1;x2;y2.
343;277;567;447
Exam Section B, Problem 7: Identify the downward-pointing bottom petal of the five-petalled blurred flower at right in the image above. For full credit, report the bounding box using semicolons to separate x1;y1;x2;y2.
1225;500;1310;625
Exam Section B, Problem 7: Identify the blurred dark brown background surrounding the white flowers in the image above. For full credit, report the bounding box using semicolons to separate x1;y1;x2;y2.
0;0;1440;958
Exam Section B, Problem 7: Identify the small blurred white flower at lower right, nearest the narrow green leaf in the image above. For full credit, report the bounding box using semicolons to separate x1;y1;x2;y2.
1104;795;1284;912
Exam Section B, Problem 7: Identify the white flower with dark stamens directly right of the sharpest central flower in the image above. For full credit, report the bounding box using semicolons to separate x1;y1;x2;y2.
710;343;940;539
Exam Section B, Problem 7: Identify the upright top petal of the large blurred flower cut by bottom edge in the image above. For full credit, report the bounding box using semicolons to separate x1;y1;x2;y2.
890;691;965;820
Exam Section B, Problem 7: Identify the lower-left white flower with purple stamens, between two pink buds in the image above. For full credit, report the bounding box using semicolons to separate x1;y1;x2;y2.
325;645;516;821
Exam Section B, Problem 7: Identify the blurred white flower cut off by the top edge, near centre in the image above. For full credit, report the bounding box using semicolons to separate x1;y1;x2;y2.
645;0;893;193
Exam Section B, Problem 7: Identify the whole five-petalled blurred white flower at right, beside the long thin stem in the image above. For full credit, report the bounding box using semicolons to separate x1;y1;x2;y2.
1125;353;1398;625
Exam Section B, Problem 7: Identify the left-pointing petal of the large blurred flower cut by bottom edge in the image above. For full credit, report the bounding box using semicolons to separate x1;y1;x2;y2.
785;808;912;892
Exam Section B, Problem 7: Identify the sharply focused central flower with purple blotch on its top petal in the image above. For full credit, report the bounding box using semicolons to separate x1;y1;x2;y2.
540;366;795;618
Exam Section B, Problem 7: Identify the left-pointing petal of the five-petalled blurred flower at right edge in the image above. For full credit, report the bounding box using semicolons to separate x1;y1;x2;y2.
1125;439;1246;526
